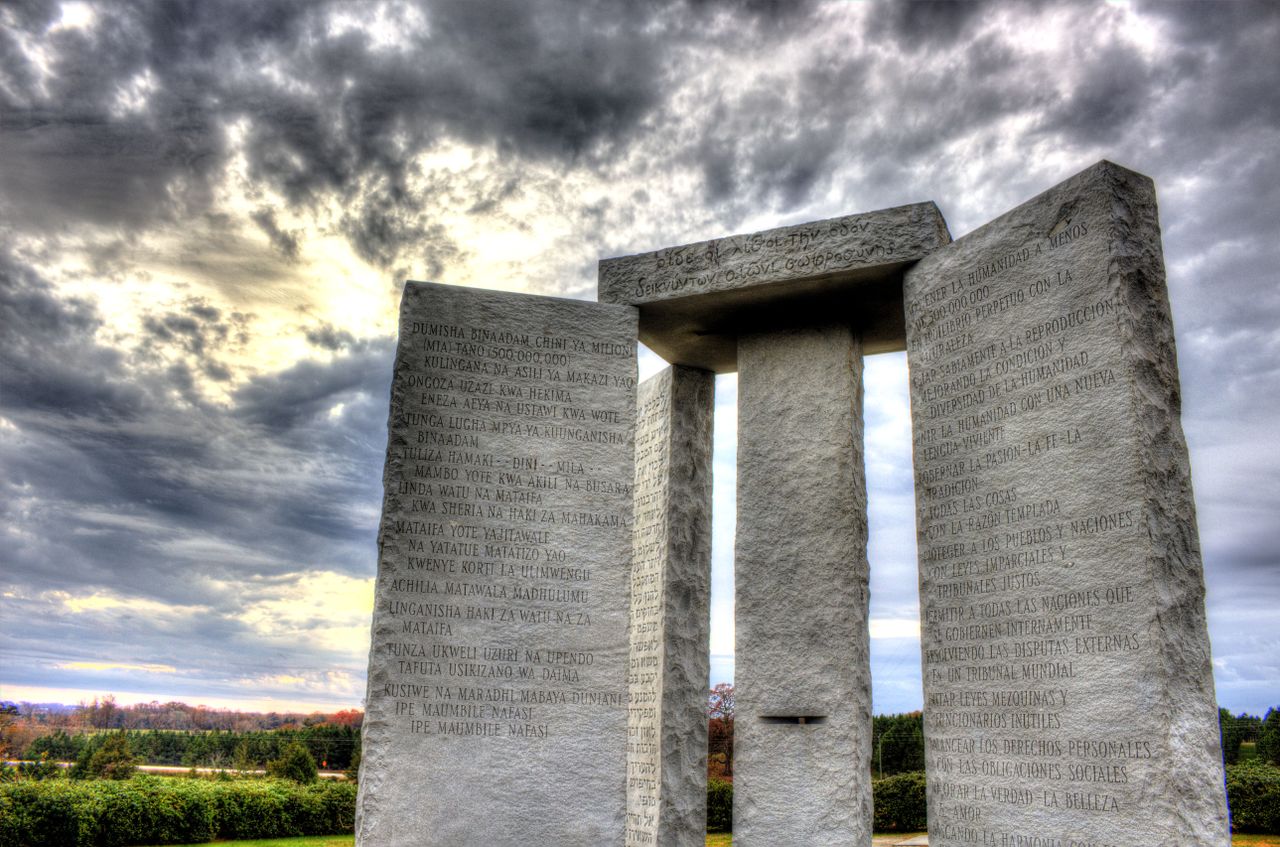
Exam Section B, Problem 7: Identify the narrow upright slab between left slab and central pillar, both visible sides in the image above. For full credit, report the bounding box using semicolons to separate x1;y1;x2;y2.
626;366;716;847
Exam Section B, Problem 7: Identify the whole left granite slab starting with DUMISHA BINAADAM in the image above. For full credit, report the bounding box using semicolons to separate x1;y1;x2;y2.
356;283;636;847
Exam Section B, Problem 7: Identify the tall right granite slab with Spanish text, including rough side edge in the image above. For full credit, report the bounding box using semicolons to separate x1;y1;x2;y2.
905;162;1230;847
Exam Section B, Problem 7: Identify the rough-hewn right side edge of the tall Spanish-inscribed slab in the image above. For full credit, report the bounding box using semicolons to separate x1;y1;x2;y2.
1094;161;1230;847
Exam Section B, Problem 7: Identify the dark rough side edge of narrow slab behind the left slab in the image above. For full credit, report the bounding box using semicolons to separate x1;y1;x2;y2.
658;365;716;847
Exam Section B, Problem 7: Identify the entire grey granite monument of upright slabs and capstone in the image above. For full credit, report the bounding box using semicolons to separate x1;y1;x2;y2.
357;161;1230;847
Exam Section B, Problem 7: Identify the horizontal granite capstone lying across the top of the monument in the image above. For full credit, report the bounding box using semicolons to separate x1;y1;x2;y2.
598;202;951;374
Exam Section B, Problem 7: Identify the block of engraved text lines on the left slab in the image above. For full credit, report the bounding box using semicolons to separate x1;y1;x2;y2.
375;321;634;740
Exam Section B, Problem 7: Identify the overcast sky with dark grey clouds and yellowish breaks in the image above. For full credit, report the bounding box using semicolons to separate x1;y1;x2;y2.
0;0;1280;714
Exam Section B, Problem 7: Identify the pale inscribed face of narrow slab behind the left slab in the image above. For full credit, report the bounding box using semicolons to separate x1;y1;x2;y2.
626;374;671;847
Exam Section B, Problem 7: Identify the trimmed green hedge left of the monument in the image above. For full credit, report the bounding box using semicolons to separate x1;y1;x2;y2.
0;777;356;847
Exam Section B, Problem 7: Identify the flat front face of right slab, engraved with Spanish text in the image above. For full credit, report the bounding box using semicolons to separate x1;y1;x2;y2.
908;210;1172;847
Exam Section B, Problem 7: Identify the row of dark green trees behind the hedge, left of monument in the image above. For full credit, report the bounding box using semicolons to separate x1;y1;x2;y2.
23;723;360;770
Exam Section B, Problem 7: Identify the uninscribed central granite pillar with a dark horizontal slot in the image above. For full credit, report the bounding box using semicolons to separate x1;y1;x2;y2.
733;325;872;847
